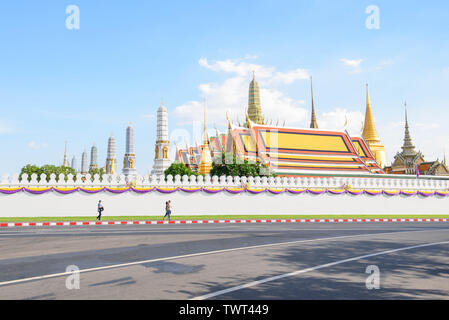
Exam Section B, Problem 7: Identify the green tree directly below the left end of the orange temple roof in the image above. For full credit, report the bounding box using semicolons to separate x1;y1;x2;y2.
210;152;276;177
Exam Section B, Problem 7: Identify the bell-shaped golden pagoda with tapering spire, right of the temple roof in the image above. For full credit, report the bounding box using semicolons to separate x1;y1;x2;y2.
362;84;387;168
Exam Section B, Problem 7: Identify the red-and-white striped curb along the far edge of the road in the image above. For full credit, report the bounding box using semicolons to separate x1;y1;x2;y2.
0;218;449;228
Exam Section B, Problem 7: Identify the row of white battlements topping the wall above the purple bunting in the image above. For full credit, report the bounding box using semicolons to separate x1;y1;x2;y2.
0;174;449;191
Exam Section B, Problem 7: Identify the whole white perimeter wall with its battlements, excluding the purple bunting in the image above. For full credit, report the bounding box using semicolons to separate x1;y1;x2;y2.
0;176;449;217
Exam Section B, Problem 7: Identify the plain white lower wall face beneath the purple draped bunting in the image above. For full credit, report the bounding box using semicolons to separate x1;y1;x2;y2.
0;191;449;217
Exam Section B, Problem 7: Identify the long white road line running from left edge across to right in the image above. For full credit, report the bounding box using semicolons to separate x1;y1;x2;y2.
0;229;447;287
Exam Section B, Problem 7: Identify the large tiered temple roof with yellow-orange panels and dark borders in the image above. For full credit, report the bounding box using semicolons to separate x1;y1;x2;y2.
224;119;383;176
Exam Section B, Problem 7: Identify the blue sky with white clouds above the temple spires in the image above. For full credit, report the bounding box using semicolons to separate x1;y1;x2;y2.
0;0;449;174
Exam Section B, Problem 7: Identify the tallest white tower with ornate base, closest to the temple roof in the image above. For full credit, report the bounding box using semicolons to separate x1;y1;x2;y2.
151;101;171;175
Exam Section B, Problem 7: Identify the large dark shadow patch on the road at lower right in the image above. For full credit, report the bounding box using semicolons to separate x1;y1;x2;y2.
184;240;449;300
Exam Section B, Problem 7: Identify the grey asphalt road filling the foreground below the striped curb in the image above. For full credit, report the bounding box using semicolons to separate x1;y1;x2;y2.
0;222;449;299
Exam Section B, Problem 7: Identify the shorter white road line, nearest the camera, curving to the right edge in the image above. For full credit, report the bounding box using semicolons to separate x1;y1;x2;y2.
190;241;449;300
